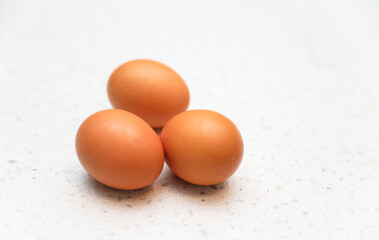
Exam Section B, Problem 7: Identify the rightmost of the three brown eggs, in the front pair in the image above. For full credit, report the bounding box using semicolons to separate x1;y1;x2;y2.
161;110;243;185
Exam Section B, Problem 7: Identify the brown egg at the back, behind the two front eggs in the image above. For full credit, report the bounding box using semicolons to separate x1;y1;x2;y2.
108;60;189;128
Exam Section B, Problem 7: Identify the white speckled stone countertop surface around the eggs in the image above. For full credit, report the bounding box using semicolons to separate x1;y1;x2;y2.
0;0;379;240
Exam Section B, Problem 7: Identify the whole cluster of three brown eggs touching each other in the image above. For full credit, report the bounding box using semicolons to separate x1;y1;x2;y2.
76;60;243;190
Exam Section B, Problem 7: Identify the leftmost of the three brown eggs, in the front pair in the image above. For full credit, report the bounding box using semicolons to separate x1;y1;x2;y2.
76;109;164;190
